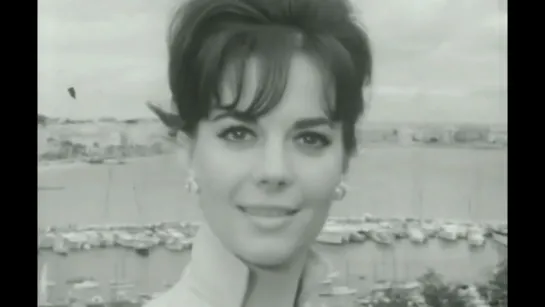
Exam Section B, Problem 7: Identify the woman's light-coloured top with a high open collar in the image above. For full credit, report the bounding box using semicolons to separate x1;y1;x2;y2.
145;225;332;307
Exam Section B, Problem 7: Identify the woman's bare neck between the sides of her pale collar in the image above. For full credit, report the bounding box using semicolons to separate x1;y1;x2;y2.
244;252;307;307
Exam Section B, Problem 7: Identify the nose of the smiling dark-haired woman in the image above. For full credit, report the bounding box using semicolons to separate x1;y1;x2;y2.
254;142;293;191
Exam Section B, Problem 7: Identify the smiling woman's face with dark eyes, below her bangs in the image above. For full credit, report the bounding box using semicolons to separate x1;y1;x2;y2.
190;54;345;267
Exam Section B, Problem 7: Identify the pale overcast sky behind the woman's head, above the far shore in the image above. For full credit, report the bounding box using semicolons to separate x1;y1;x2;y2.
38;0;507;124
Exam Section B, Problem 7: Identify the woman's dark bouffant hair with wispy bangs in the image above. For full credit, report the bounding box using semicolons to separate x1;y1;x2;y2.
168;0;372;153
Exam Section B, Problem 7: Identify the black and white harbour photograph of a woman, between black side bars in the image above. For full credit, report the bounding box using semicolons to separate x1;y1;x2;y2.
37;0;506;307
